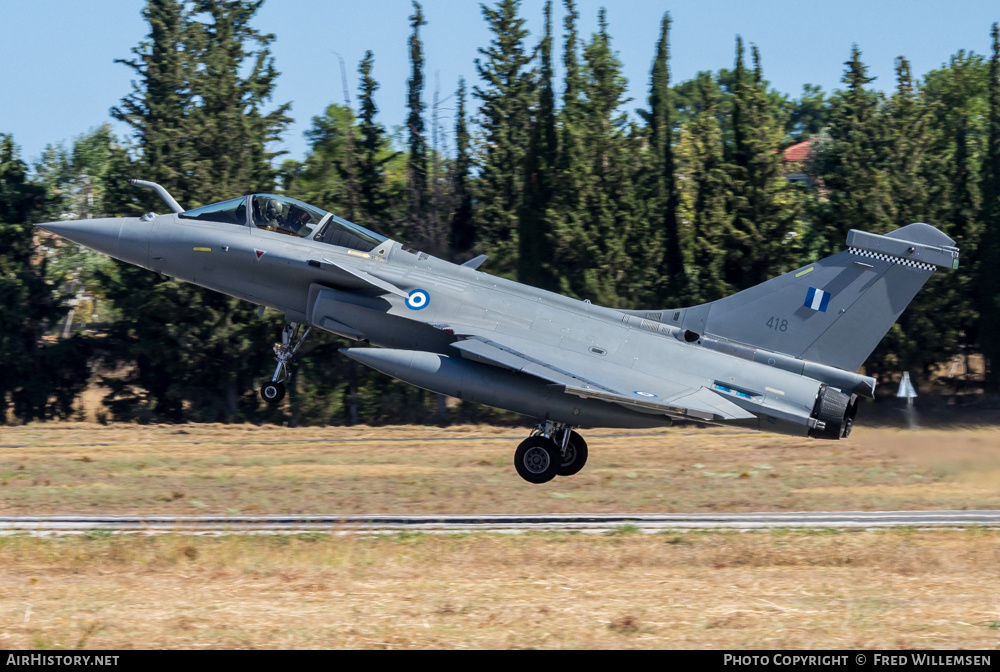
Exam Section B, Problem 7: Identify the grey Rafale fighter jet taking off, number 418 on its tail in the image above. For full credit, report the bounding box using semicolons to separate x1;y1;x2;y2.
38;180;959;483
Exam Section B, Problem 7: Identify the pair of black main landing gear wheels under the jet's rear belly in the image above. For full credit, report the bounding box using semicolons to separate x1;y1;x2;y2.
514;421;587;483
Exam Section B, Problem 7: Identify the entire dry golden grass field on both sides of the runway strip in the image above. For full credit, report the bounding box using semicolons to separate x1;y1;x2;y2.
0;424;1000;649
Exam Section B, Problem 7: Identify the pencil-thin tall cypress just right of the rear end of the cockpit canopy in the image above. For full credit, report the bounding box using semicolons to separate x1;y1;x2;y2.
406;0;428;239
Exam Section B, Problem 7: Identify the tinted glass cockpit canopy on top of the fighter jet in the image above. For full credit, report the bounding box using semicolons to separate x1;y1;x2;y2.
178;194;388;252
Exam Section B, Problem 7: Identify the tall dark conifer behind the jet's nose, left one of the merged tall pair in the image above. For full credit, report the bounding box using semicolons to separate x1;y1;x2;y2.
98;0;194;420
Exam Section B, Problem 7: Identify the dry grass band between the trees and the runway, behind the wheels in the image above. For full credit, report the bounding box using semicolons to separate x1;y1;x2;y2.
0;424;1000;515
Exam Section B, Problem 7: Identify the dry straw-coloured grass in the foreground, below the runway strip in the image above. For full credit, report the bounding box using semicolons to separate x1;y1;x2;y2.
0;530;1000;650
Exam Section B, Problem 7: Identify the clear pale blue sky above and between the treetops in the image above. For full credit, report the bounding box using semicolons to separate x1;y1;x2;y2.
0;0;1000;160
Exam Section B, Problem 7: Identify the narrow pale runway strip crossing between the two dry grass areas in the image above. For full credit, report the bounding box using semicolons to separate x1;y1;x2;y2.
0;511;1000;536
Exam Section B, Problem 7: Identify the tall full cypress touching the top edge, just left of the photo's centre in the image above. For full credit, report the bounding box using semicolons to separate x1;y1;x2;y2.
473;0;531;277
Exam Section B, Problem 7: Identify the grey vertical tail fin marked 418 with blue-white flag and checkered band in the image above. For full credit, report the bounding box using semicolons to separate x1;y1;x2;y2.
639;224;958;371
